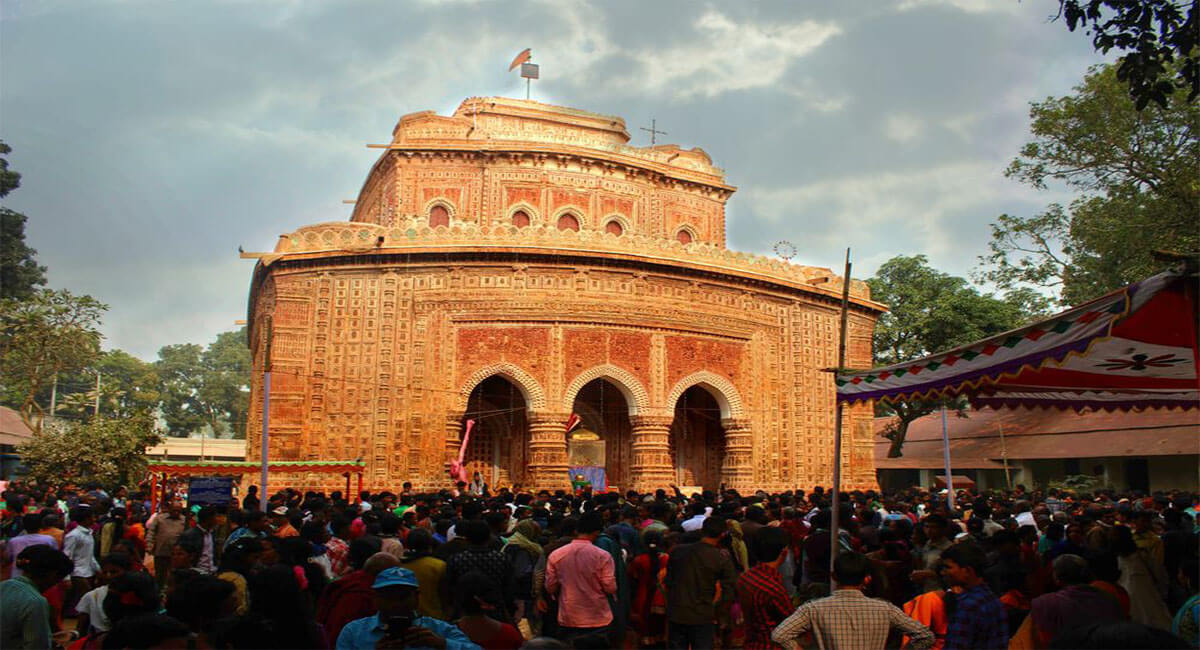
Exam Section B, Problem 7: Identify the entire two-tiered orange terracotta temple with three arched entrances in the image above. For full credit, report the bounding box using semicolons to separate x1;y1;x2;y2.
247;97;883;490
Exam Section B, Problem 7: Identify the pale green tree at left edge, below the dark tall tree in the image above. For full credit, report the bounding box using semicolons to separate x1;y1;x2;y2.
0;289;108;432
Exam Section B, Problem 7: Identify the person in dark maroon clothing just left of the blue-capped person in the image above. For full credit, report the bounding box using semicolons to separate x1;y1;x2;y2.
317;537;400;648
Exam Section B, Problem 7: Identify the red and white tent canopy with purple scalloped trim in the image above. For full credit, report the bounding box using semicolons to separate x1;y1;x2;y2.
835;271;1200;411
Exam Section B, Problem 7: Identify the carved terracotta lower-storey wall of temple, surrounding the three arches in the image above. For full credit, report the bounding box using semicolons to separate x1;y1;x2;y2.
247;257;874;488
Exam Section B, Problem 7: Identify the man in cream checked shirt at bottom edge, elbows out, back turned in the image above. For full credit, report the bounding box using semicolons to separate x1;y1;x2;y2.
770;552;934;650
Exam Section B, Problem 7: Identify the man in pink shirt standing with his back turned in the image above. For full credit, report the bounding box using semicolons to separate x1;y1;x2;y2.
546;511;617;640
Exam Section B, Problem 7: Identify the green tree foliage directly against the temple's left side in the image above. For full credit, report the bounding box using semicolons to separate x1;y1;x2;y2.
155;331;251;438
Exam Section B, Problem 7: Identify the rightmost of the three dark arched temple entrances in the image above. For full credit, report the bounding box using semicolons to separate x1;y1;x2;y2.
671;386;725;490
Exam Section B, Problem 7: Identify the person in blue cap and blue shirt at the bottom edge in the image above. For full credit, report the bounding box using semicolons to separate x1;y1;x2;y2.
337;566;481;650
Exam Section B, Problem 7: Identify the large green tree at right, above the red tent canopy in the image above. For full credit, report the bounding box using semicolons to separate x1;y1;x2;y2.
977;66;1200;305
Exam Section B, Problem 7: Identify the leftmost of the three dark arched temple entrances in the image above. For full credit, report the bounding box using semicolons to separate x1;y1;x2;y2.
462;375;529;492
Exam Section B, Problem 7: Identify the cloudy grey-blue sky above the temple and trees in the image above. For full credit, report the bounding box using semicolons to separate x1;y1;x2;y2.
0;0;1102;360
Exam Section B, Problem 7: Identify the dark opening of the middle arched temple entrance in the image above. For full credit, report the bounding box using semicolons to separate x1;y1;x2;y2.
568;379;632;489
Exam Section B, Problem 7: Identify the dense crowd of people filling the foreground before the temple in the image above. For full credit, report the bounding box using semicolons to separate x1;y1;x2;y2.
0;482;1200;650
